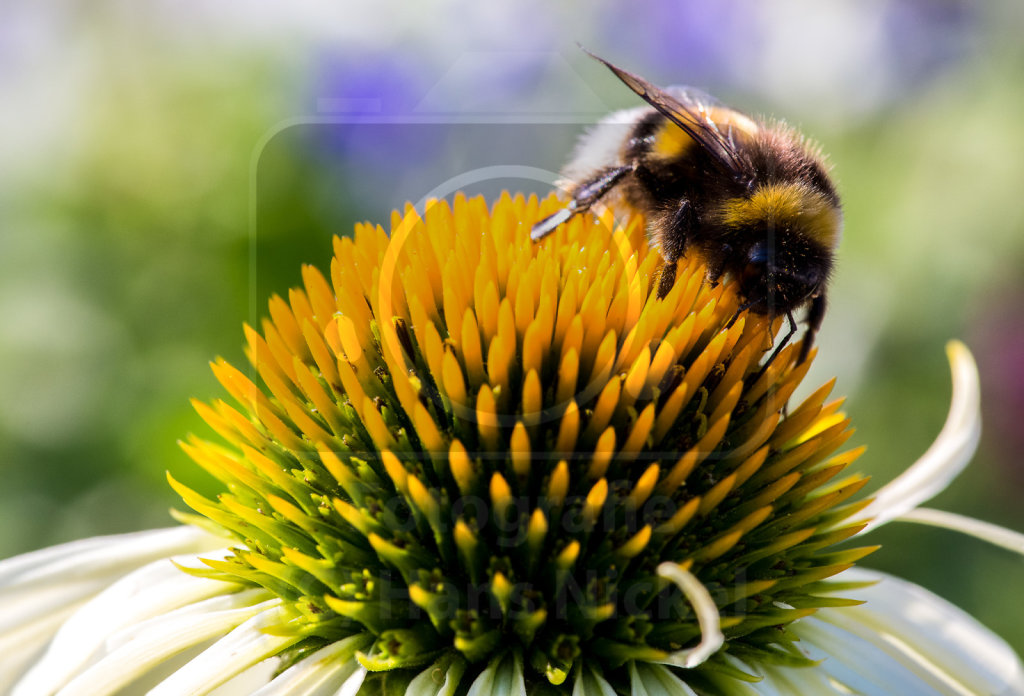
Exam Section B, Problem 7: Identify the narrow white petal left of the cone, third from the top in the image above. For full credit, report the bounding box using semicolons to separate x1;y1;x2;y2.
48;590;281;696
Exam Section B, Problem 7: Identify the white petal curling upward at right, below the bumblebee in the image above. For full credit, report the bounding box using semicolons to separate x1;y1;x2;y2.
856;341;981;533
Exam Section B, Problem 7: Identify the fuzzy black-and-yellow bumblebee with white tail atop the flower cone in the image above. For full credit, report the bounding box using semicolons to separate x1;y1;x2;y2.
530;53;843;364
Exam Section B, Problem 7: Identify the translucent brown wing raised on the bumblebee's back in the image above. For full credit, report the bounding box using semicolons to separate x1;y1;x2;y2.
584;49;743;177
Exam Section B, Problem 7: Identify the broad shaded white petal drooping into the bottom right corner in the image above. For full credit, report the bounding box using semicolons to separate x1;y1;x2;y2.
752;569;1024;696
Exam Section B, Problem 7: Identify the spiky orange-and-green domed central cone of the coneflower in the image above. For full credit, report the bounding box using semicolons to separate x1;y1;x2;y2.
174;190;869;693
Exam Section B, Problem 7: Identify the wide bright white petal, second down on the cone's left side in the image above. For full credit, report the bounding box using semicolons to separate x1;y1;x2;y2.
13;552;242;695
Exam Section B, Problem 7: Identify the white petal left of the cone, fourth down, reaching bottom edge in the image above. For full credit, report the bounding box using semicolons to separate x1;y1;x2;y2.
144;600;299;696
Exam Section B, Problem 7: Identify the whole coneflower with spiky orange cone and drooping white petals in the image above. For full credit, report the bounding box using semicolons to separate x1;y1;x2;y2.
0;197;1024;696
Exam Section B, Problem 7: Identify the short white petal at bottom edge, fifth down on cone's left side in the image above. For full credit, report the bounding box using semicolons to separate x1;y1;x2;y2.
252;634;373;696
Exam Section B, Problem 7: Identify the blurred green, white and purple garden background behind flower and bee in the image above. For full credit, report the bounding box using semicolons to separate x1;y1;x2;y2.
0;0;1024;652
